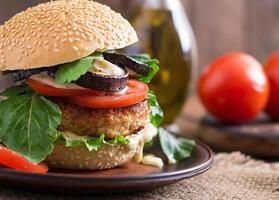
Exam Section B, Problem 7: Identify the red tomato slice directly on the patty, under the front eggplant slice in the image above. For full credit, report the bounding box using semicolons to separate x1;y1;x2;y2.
70;80;148;109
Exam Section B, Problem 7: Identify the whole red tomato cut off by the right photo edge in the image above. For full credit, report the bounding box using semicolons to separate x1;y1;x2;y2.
265;51;279;119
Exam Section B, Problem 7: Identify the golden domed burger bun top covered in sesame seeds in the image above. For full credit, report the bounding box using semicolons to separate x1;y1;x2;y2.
0;0;138;71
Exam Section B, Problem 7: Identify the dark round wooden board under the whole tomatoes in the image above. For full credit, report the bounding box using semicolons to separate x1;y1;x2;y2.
200;116;279;157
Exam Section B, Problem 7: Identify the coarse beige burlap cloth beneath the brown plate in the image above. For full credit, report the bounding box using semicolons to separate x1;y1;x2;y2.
0;153;279;200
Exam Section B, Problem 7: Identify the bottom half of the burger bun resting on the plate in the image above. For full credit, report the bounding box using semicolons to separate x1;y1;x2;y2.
44;131;145;170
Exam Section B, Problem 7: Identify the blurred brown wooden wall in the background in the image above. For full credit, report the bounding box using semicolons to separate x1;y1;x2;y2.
0;0;279;70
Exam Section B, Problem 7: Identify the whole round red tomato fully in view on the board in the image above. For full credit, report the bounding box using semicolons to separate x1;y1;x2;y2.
198;53;269;123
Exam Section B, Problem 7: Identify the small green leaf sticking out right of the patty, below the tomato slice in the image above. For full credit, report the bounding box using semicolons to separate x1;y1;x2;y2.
147;91;164;128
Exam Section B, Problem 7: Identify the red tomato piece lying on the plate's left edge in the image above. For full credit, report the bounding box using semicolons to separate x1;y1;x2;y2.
0;146;48;174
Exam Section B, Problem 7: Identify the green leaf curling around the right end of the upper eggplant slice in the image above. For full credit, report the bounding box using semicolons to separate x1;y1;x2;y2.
129;54;160;83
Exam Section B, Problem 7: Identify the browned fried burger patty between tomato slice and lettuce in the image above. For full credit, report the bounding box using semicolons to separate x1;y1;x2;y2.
52;99;150;139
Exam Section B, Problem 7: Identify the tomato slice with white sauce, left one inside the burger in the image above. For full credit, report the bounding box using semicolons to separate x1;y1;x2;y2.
27;74;100;97
